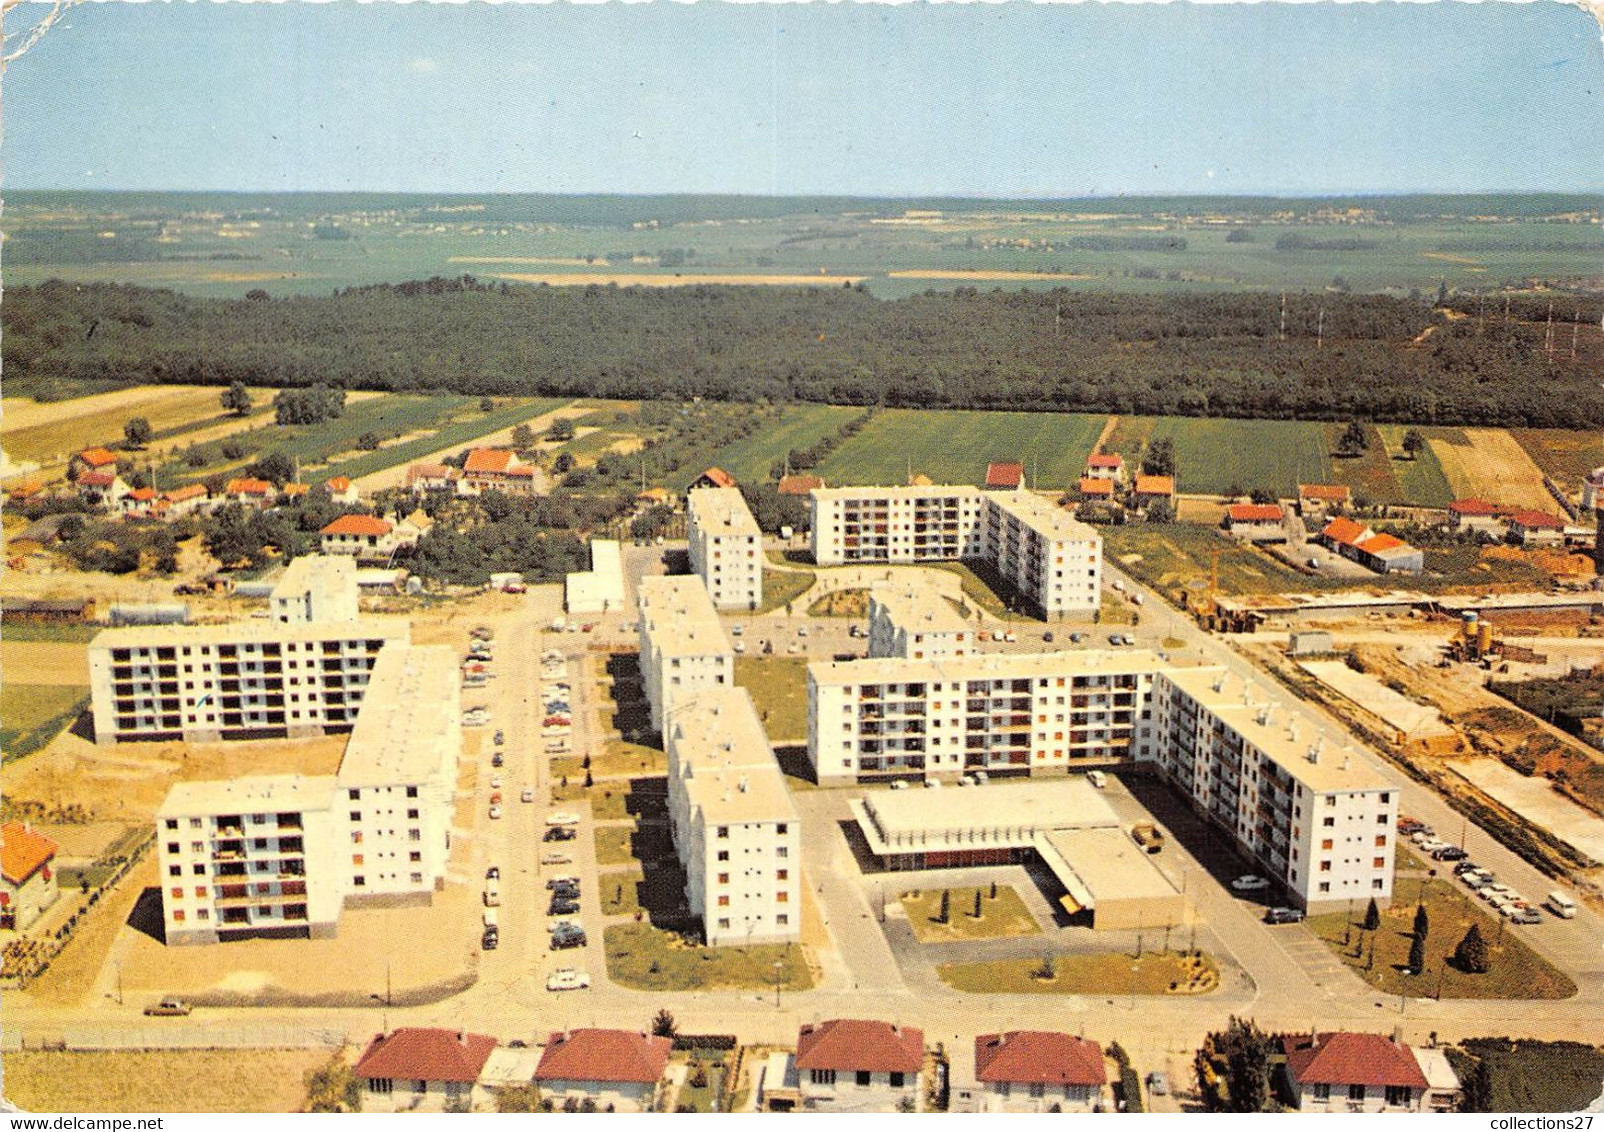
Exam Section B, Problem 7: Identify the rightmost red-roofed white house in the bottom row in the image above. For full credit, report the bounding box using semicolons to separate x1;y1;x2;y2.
1282;1031;1429;1113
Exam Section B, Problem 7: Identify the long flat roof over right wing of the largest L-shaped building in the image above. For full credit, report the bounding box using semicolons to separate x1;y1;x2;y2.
1160;667;1399;792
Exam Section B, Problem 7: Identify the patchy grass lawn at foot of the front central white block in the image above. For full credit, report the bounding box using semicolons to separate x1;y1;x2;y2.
605;924;813;991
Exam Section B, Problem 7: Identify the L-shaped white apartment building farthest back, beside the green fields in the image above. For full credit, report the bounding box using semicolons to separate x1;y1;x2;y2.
810;486;1102;619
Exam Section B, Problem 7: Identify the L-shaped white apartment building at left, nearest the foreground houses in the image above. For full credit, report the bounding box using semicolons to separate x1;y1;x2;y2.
156;643;460;944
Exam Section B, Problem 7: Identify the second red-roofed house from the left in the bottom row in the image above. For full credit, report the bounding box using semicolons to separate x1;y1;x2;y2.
534;1029;674;1113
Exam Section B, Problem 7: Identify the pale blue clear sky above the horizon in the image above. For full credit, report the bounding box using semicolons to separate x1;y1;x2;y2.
0;0;1604;197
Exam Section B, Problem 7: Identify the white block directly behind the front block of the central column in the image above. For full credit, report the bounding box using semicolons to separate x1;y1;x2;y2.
637;574;735;731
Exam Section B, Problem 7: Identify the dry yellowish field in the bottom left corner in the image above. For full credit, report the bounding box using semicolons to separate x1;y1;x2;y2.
0;1049;329;1113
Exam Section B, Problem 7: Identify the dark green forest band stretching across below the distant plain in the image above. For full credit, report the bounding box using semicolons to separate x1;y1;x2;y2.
12;276;1604;428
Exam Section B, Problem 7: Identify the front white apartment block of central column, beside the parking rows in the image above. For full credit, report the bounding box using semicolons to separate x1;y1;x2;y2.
666;686;802;946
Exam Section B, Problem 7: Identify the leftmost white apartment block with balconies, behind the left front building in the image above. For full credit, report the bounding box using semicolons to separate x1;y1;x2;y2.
88;619;411;744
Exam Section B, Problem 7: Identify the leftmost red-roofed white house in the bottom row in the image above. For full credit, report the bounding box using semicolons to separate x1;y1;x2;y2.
351;1026;496;1113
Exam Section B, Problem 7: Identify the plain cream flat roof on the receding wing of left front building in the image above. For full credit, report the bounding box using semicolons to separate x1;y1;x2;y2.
340;645;462;787
